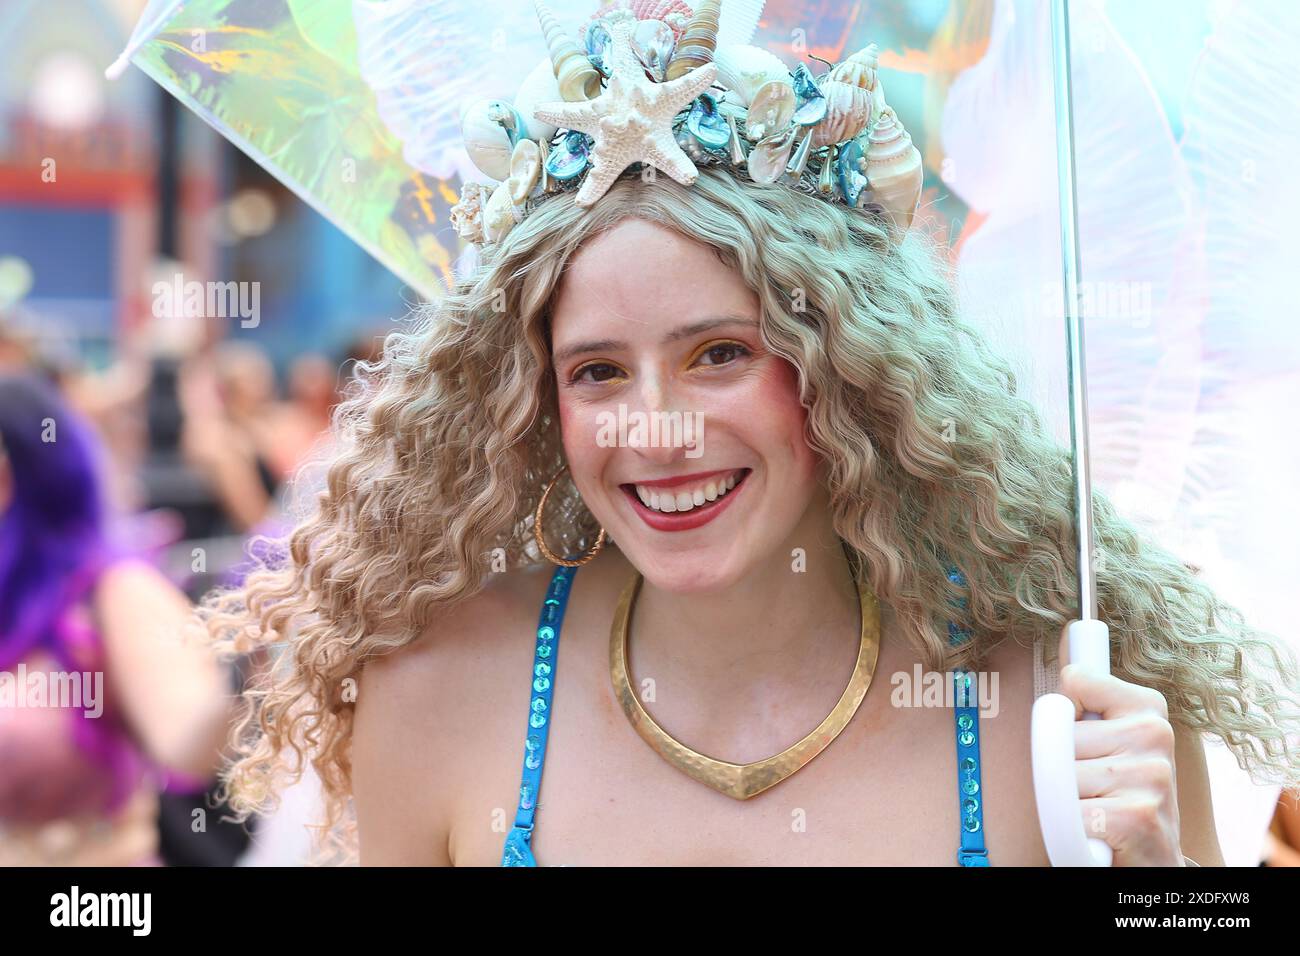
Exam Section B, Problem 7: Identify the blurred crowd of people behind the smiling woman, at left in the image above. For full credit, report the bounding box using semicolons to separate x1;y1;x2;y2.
0;277;392;865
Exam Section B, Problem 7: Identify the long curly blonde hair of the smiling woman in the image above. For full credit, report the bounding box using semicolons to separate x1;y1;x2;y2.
200;162;1300;858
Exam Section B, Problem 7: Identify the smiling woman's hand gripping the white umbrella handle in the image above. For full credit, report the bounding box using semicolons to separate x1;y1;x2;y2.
1061;621;1186;866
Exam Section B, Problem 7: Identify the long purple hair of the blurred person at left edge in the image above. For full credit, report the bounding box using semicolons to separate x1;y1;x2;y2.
0;375;143;810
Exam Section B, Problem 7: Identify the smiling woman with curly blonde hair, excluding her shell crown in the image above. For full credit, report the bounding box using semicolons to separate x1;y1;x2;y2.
195;169;1300;865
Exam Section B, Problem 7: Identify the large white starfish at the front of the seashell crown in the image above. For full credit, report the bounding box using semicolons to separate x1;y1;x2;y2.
533;20;718;207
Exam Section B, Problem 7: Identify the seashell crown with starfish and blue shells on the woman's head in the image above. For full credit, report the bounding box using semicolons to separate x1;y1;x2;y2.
451;0;923;245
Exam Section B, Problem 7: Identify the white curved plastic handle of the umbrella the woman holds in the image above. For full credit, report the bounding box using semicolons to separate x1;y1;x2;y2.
1031;620;1112;866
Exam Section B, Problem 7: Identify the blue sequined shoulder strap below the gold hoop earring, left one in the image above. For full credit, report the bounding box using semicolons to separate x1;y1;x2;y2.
501;567;577;866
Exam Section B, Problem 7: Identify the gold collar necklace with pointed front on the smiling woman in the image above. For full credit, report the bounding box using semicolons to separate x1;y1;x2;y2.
610;545;880;800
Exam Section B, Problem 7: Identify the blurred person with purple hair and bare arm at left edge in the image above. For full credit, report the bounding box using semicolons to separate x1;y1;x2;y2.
0;375;230;866
